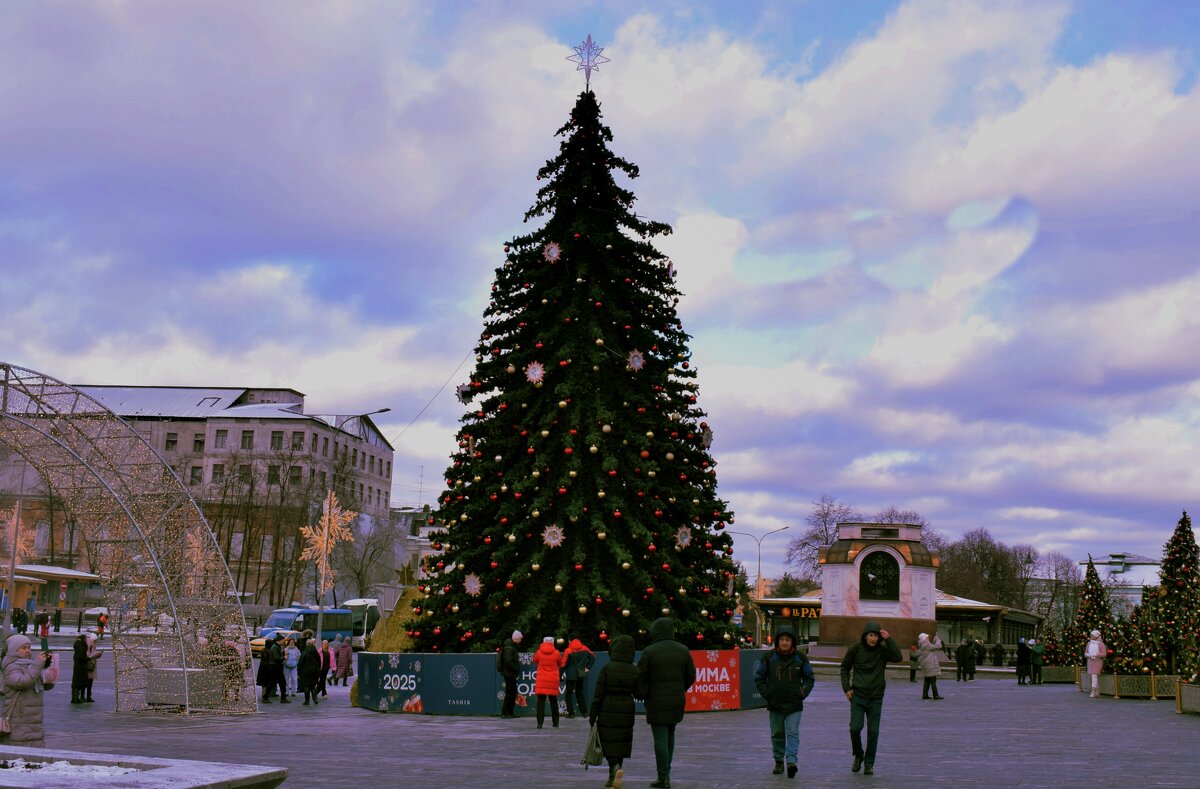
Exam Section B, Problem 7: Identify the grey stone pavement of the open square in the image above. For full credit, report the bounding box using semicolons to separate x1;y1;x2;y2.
39;661;1200;789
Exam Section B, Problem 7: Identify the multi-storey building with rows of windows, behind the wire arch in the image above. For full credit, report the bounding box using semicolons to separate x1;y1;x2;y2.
68;385;392;604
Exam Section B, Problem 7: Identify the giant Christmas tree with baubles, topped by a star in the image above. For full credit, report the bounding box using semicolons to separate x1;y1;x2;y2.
407;46;736;651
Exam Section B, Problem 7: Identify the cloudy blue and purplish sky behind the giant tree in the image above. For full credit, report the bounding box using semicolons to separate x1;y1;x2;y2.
0;0;1200;574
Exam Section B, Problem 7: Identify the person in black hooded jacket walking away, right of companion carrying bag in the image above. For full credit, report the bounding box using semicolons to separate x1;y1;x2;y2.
637;616;696;789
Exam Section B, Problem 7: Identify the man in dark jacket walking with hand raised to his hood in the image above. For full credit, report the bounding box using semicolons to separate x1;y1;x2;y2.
841;622;904;776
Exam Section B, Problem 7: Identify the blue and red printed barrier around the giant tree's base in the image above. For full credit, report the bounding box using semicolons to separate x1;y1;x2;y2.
358;650;767;716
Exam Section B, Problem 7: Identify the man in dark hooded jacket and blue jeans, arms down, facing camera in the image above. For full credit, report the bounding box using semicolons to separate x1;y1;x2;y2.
754;625;816;778
